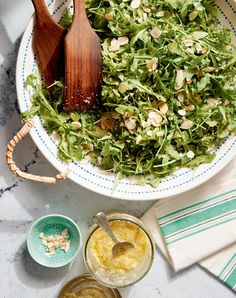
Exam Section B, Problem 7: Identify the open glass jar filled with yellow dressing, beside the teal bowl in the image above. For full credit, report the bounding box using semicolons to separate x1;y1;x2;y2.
84;212;154;288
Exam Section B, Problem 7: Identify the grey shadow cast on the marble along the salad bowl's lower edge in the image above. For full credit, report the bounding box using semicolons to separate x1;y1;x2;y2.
8;176;152;225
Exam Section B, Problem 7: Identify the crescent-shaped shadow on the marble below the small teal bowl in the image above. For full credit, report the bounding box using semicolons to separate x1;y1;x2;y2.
13;242;70;289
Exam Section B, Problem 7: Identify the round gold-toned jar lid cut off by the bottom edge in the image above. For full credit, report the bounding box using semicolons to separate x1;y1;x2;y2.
58;274;122;298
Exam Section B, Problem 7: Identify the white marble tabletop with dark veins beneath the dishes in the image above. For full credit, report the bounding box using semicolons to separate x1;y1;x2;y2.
0;0;234;298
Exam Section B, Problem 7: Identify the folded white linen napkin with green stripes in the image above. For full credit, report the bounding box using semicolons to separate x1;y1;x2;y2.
142;158;236;291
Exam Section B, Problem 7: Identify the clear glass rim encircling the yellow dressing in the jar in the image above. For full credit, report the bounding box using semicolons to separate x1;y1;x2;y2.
83;211;155;288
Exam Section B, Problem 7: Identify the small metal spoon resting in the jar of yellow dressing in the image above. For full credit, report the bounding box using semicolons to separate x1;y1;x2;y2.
93;212;134;258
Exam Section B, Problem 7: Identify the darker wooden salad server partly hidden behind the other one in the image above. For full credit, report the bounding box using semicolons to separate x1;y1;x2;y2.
32;0;66;86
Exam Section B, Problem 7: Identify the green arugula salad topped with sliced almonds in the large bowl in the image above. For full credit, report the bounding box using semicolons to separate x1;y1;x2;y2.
23;0;236;187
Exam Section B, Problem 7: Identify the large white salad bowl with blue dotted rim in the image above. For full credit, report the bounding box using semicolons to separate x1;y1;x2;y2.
16;0;236;201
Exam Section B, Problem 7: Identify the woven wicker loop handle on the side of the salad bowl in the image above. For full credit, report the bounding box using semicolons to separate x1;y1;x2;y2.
6;119;69;184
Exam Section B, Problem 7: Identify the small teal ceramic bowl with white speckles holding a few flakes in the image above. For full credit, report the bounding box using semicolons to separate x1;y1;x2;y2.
27;214;82;268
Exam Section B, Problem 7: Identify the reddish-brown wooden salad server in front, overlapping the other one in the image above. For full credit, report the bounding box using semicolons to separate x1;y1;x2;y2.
63;0;102;111
